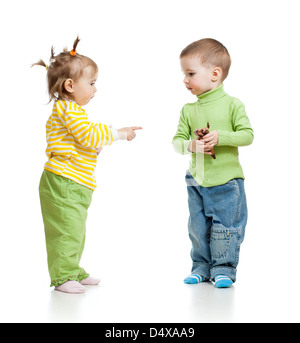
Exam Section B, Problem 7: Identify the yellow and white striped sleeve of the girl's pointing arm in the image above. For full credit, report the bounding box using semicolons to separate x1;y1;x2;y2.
56;100;119;148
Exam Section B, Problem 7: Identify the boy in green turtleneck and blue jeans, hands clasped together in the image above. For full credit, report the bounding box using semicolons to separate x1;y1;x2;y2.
173;39;254;288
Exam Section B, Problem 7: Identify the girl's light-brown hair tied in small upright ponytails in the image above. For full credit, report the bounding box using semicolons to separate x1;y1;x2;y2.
32;37;98;102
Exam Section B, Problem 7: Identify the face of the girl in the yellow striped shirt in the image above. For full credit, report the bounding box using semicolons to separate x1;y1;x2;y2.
72;66;98;106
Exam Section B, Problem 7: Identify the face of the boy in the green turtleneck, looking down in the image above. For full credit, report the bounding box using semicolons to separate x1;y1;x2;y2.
180;56;221;95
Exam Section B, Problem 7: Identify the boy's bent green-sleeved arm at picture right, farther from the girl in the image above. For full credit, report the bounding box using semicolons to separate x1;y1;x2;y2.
217;101;254;147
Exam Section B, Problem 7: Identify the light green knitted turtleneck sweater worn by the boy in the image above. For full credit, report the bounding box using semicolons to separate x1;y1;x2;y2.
173;84;254;187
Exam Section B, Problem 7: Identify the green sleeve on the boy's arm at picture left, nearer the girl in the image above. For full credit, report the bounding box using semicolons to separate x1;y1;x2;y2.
172;108;191;155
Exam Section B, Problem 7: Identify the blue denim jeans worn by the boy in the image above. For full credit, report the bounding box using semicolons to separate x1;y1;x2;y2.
186;171;247;282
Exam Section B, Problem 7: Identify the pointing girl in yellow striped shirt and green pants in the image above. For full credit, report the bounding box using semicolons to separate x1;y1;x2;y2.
33;37;141;293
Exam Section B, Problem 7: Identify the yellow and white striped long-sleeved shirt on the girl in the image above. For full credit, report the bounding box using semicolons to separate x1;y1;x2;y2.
45;100;119;190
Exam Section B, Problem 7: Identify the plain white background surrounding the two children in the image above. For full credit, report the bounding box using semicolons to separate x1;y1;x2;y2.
0;0;300;323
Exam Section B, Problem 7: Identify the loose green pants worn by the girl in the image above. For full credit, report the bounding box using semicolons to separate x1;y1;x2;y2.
39;170;93;286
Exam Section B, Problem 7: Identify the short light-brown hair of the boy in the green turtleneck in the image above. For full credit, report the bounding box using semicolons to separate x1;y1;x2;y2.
180;38;231;82
